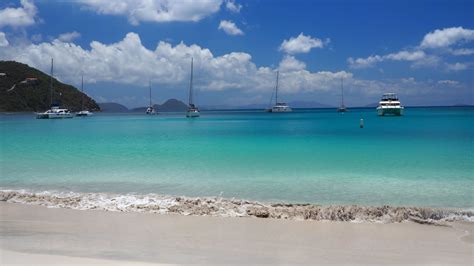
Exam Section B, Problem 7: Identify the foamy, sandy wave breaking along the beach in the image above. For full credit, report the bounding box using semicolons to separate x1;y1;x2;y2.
0;190;474;224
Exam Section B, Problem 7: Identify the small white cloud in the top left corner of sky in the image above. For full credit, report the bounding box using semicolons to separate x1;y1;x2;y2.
0;0;38;28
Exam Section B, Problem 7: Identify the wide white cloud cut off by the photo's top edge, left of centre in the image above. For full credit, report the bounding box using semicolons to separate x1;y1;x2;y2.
79;0;222;25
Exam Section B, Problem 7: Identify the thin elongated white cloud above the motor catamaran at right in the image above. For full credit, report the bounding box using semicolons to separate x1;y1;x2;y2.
348;50;426;68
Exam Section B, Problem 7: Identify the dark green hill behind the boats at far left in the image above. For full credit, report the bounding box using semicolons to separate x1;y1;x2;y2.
0;61;100;112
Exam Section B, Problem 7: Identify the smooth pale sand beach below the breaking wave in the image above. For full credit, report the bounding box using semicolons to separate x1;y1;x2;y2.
0;202;474;265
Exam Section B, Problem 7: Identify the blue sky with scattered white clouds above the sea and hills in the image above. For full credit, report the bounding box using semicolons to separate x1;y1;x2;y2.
0;0;474;108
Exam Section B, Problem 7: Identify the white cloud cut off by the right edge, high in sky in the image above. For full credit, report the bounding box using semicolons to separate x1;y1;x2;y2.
420;27;474;48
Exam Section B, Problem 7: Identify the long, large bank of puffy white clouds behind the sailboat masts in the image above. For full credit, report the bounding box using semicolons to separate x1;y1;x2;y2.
0;33;358;95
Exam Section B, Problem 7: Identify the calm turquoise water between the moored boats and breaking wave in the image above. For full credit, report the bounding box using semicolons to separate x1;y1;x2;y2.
0;108;474;208
